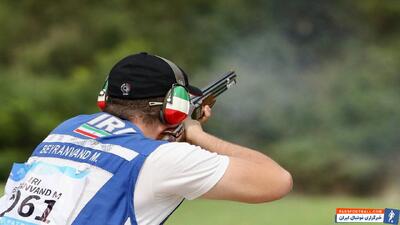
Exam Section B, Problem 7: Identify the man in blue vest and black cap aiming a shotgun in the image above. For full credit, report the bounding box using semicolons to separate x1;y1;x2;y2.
0;53;292;225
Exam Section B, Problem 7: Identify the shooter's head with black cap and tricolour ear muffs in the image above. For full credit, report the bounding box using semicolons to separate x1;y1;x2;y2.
98;53;202;128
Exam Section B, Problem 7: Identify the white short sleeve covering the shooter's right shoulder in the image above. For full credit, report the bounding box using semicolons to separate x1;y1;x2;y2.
141;143;229;199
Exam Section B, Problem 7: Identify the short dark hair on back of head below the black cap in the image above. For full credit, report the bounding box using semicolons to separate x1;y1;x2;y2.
104;97;164;125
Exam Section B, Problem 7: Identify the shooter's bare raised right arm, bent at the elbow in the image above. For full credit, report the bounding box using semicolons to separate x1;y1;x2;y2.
185;108;292;203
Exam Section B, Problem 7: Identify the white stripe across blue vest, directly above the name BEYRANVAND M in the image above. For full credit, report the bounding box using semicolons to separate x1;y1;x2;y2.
43;134;139;161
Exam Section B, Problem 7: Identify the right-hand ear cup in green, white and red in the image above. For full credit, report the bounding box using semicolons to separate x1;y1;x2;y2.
164;86;190;124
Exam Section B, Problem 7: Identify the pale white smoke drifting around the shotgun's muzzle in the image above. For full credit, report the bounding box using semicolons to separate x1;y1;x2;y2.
194;33;313;144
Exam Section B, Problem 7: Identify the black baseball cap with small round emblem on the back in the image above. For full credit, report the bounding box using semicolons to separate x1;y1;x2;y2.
107;52;202;99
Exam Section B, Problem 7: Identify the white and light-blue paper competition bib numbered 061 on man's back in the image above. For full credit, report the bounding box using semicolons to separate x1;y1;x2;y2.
0;162;89;225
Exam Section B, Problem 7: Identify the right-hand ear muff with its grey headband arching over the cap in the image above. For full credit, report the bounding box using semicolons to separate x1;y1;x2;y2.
157;56;190;125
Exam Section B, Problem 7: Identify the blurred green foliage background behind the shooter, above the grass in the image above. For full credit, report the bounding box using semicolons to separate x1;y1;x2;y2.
0;0;400;194
